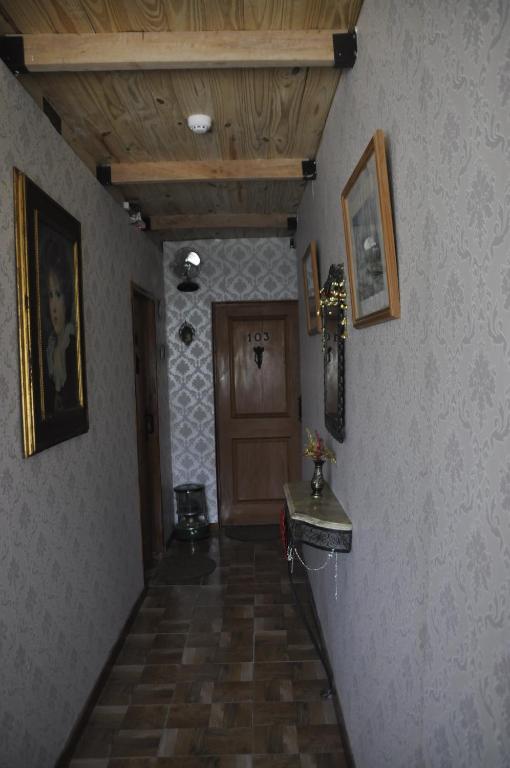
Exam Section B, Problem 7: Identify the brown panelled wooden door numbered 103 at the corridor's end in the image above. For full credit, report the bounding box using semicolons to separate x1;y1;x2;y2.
213;301;301;525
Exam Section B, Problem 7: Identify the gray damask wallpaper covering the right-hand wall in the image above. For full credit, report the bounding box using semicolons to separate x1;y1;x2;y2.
298;0;510;768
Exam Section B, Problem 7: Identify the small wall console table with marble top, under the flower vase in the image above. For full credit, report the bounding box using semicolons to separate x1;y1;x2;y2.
283;480;352;696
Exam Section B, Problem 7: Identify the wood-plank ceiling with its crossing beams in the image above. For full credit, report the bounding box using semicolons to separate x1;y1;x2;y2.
0;0;362;240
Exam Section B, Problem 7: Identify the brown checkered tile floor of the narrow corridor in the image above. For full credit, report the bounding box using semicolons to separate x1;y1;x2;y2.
70;536;347;768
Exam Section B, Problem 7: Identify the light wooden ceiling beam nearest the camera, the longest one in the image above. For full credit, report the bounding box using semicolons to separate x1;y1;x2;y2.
7;29;346;72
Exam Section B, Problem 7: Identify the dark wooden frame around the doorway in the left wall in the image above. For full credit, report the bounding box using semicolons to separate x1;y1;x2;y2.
131;281;165;570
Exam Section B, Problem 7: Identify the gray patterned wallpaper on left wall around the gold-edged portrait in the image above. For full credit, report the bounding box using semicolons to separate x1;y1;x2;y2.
0;64;171;768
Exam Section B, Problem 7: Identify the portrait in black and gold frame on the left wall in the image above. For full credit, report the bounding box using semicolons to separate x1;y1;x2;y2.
14;169;88;456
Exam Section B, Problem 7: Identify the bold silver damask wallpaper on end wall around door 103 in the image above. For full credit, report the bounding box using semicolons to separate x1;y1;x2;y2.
163;238;297;521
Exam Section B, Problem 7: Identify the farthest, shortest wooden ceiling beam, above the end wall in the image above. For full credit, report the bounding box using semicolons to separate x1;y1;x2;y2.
150;213;296;232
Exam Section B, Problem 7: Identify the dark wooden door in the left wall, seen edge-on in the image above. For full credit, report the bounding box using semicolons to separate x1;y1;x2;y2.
132;287;164;571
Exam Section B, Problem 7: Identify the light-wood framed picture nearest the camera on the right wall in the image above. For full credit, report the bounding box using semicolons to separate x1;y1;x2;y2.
342;130;400;328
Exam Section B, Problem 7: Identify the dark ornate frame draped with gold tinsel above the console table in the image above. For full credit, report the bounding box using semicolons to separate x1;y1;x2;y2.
321;264;346;443
